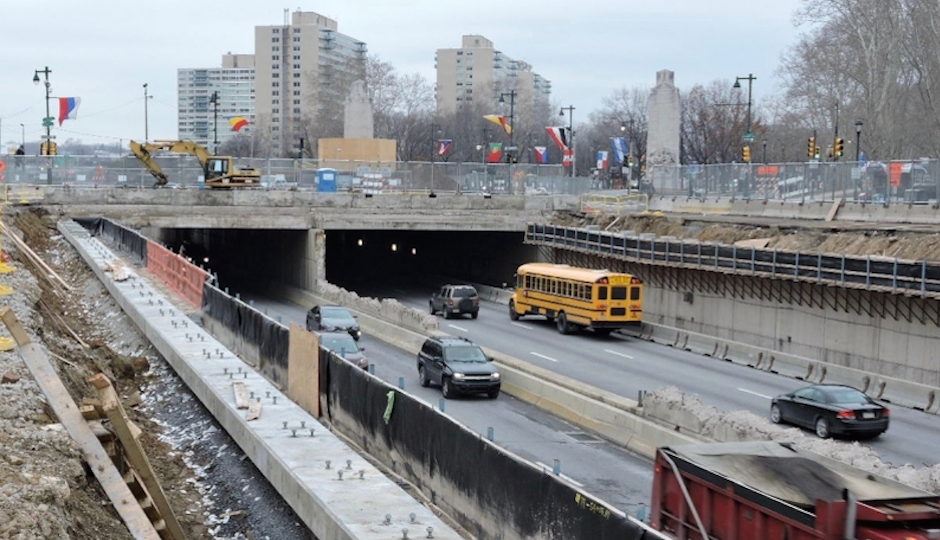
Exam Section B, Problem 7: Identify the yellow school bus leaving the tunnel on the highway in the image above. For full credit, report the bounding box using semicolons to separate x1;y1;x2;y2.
509;263;643;335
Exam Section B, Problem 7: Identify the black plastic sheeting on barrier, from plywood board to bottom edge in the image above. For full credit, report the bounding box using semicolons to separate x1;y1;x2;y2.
320;350;648;540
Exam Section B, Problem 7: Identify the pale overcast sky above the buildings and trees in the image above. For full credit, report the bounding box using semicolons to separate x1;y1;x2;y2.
0;0;802;146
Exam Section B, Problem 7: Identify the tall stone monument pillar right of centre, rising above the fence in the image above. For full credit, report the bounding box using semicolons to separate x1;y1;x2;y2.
646;69;682;194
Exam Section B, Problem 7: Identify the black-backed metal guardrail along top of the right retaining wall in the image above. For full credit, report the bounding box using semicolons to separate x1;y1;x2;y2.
525;225;940;298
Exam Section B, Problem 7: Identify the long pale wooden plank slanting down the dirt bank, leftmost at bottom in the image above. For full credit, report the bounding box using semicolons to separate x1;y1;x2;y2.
0;307;160;540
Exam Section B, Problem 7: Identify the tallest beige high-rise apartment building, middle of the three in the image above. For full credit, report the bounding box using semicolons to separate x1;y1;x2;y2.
255;11;368;155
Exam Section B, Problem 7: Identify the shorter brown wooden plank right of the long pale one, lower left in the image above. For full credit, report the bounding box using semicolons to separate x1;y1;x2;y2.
89;373;186;540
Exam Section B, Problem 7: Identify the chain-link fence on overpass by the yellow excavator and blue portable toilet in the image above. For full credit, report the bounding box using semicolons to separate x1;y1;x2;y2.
0;155;598;195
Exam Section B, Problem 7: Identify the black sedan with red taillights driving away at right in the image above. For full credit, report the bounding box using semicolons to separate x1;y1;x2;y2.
770;384;891;439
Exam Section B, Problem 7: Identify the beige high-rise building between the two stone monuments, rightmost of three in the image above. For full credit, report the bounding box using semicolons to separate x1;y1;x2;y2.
435;35;552;114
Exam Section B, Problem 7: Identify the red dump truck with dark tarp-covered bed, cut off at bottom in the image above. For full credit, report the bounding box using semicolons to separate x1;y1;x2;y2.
650;442;940;540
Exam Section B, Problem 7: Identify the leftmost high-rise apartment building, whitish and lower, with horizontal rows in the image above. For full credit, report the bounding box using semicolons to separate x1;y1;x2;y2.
176;53;255;152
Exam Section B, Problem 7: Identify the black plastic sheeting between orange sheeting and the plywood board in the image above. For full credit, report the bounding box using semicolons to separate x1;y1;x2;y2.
202;283;290;386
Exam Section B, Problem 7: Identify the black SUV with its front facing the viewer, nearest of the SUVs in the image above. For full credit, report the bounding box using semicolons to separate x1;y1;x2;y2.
418;337;501;399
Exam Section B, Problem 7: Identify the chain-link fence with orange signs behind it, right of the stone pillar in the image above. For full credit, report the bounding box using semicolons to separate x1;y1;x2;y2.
641;159;940;204
